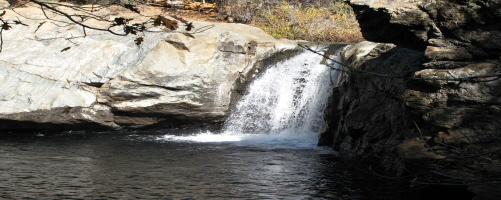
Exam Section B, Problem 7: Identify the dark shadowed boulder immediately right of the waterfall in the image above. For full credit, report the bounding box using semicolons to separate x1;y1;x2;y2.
321;41;423;162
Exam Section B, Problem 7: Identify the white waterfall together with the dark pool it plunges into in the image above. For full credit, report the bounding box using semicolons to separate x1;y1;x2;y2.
0;45;414;200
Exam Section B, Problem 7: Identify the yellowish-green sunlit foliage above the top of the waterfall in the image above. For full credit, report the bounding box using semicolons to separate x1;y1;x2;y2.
255;1;363;43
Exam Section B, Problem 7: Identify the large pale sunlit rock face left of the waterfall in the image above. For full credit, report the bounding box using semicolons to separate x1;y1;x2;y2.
0;6;296;129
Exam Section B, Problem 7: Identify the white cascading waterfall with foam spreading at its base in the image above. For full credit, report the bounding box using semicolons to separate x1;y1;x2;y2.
158;45;345;146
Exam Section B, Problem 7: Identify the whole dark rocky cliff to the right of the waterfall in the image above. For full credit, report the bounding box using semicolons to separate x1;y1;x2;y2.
320;0;501;199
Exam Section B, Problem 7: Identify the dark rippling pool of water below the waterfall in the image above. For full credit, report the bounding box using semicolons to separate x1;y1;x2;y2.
0;132;412;199
